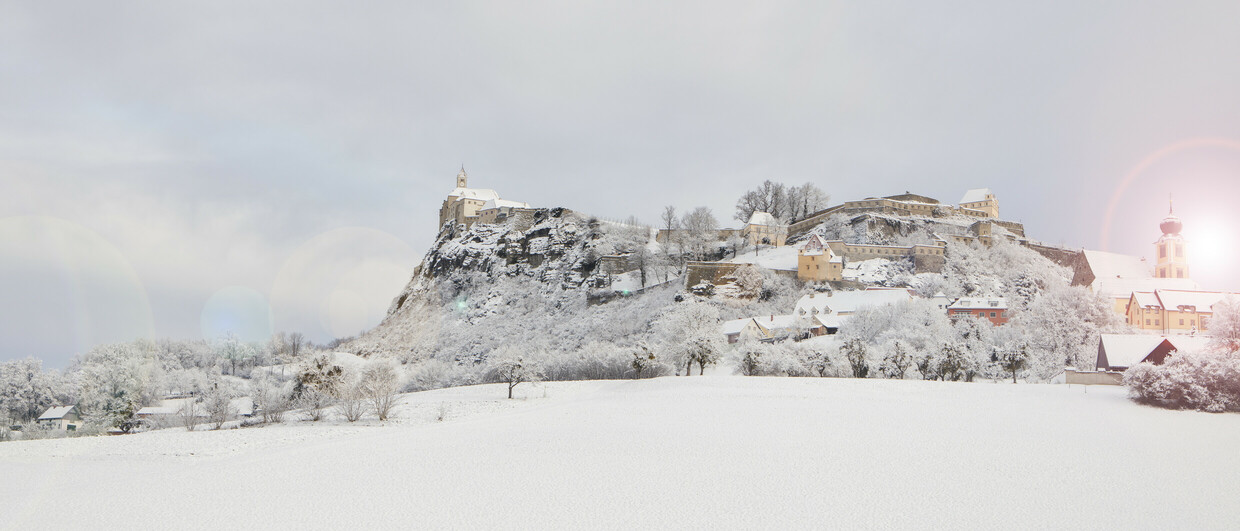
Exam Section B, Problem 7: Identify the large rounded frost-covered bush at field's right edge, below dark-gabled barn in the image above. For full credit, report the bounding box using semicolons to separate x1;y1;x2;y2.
1123;351;1240;412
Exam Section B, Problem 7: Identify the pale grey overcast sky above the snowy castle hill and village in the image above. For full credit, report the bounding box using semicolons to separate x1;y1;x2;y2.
0;0;1240;366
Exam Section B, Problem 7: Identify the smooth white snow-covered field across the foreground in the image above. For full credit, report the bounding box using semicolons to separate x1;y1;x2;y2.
0;376;1240;530
